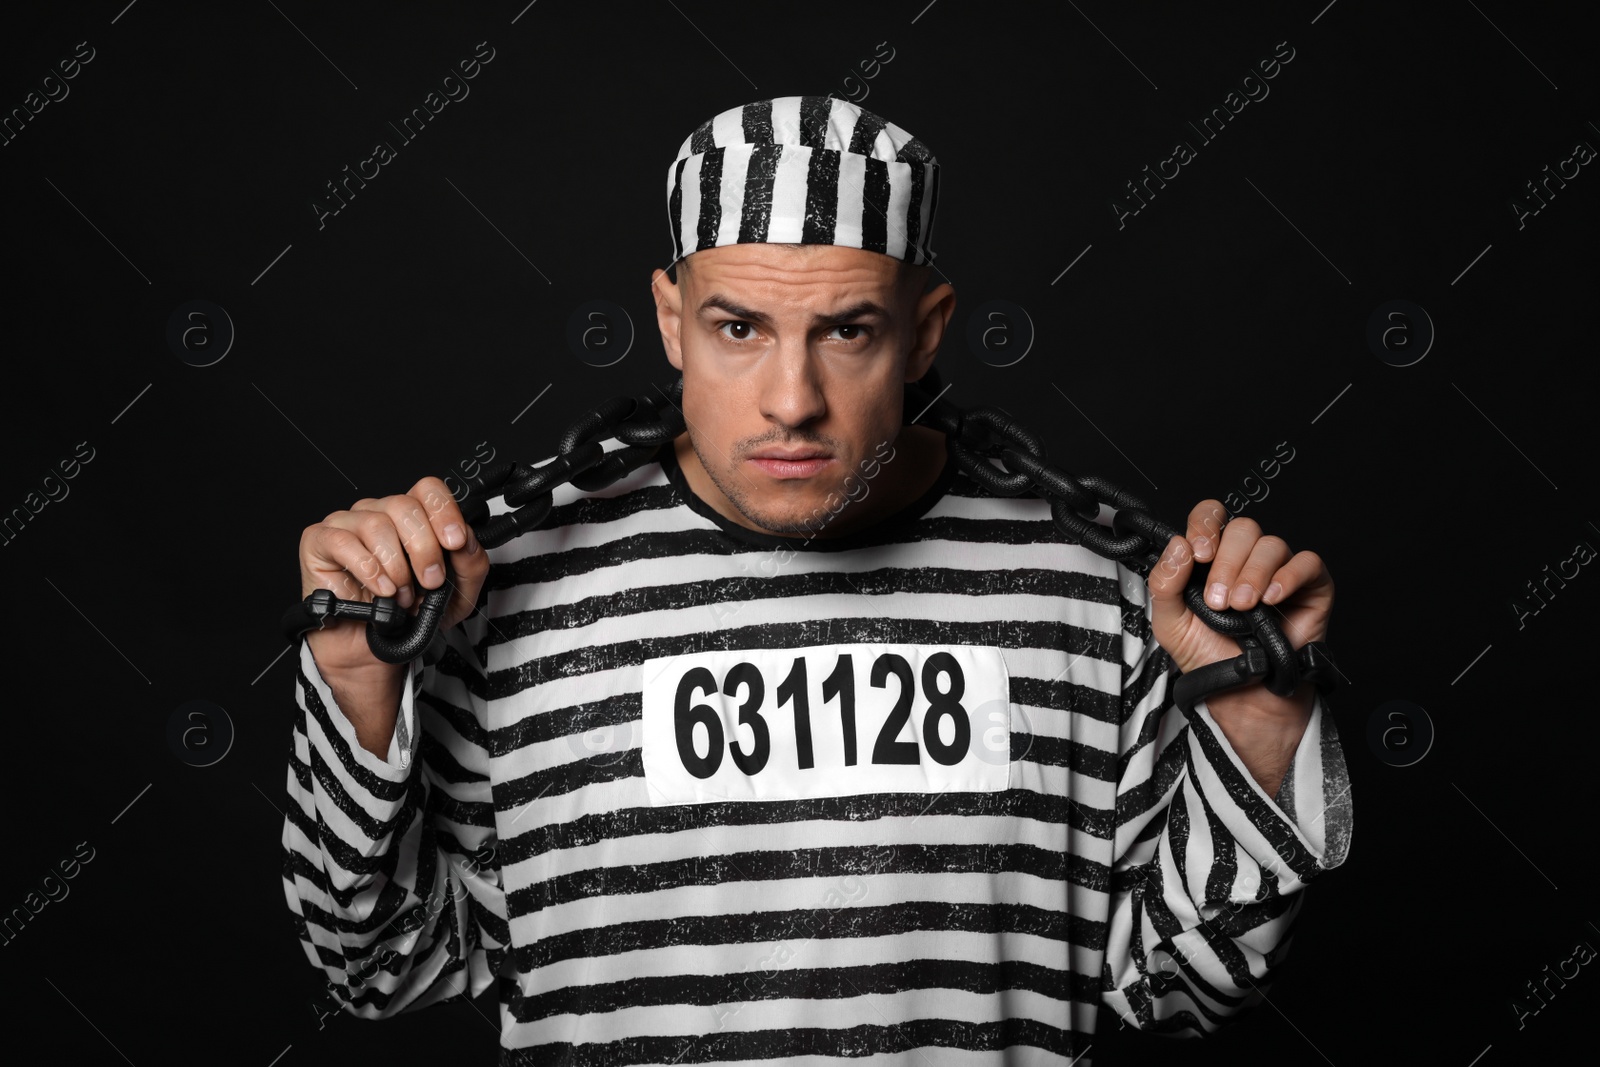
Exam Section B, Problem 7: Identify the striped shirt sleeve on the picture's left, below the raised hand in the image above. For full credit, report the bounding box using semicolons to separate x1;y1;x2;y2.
283;611;510;1019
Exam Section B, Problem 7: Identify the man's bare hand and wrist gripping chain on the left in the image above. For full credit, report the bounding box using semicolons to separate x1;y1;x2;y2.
299;478;490;757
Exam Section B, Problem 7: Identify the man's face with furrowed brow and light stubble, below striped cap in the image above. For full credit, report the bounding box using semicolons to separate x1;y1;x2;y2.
654;243;954;534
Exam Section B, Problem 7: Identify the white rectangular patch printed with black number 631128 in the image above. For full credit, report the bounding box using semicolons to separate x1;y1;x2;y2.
642;645;1011;805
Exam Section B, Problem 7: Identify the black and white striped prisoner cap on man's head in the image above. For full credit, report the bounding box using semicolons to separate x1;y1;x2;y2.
667;96;939;264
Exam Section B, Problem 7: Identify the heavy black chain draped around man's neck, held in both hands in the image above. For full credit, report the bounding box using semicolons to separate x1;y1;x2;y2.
282;370;1336;712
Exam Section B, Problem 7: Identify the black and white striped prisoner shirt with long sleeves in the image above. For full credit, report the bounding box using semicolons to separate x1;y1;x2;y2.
283;440;1350;1067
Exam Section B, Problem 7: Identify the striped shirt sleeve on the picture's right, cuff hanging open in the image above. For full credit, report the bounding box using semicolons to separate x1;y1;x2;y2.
1101;563;1352;1037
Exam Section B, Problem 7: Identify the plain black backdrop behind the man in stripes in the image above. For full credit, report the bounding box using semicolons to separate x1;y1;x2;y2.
0;0;1600;1067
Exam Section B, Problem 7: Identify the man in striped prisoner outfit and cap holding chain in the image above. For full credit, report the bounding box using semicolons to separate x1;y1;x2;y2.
283;98;1350;1065
